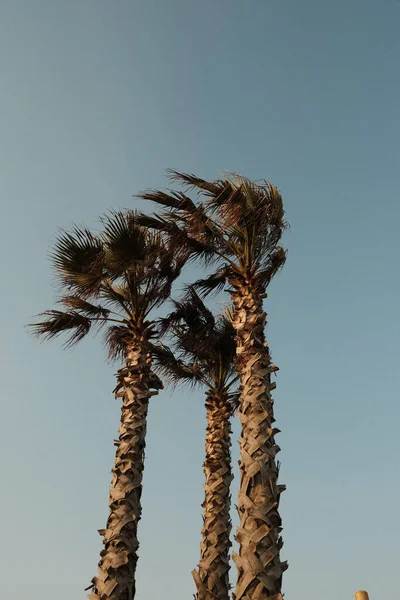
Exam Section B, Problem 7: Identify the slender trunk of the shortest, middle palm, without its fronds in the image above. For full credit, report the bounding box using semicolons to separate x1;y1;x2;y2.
192;394;233;600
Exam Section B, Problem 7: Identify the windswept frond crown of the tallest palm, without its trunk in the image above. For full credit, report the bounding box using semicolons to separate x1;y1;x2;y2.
139;171;287;294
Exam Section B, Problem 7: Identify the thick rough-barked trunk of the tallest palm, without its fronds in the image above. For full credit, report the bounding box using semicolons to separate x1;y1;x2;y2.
232;285;287;600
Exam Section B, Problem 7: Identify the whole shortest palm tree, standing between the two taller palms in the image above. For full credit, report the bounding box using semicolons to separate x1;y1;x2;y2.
154;290;238;600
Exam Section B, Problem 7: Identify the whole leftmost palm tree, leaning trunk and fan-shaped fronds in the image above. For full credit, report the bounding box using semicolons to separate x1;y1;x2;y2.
32;212;184;600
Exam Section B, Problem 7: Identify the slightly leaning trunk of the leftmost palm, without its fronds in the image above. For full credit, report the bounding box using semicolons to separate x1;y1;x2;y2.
89;339;162;600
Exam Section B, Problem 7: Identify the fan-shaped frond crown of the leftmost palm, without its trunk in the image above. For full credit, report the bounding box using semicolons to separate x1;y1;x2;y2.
32;211;184;358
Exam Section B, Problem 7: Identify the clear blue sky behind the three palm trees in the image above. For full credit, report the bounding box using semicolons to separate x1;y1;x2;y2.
0;0;400;600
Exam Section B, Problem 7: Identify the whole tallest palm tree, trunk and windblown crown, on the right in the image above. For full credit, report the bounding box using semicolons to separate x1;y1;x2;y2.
140;171;287;600
